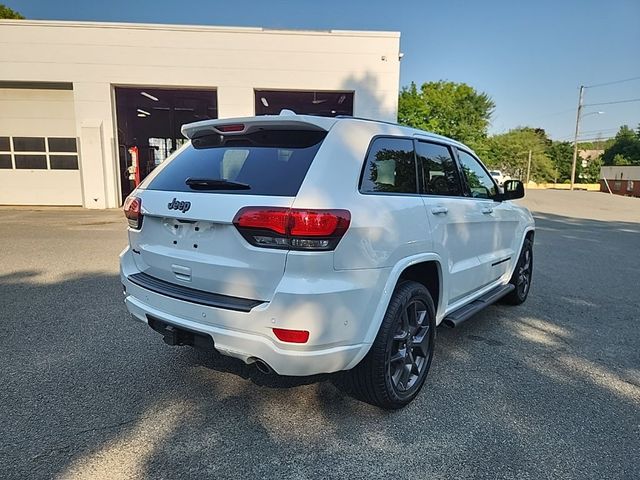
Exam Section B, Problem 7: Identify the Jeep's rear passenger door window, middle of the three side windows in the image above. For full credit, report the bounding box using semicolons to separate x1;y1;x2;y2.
416;141;462;196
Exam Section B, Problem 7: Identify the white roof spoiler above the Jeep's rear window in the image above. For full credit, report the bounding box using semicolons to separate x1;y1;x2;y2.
181;110;338;140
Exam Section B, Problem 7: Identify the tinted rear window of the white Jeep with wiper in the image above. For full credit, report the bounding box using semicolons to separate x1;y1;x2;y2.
147;130;327;197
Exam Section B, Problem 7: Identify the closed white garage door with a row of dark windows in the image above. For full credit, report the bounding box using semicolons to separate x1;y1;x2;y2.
0;85;82;205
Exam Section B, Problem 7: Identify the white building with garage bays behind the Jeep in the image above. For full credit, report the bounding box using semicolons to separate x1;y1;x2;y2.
0;20;400;208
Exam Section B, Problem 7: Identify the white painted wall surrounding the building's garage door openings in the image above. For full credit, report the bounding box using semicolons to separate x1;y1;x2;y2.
0;20;400;208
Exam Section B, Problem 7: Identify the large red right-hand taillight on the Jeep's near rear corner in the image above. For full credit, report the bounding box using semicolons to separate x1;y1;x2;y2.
233;207;351;250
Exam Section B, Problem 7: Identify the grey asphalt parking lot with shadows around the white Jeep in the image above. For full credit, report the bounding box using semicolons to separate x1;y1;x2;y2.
0;191;640;479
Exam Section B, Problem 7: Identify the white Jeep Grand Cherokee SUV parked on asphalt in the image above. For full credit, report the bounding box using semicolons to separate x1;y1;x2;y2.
120;115;534;408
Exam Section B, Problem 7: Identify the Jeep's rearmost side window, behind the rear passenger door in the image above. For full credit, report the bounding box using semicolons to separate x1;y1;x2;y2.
360;138;418;193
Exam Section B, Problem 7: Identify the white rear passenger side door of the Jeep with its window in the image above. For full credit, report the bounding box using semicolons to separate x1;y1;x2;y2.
416;140;486;304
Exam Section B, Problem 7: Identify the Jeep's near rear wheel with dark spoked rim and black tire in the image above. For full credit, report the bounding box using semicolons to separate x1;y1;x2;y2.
345;281;436;410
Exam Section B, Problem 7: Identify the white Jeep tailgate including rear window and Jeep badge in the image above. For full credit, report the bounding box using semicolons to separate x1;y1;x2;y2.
129;127;326;301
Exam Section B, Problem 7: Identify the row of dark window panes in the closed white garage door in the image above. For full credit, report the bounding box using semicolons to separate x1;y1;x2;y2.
0;137;79;170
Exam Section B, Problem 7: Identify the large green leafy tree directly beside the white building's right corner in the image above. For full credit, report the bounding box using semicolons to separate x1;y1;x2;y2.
398;80;495;145
